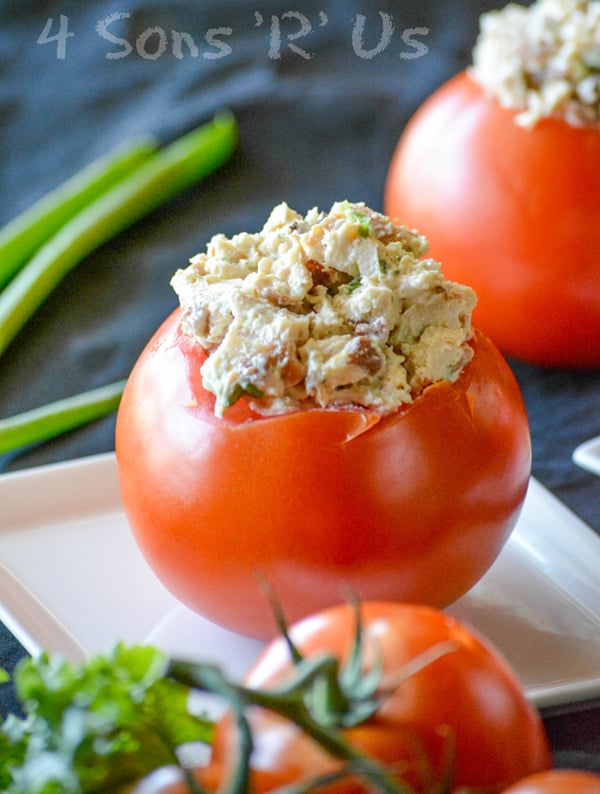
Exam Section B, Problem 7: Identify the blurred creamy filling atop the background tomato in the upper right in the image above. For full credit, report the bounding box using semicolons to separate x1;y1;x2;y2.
470;0;600;127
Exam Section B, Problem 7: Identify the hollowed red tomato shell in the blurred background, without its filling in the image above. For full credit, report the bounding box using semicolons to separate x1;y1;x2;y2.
384;73;600;367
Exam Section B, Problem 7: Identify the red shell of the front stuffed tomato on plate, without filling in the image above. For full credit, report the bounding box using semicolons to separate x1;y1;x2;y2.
116;311;531;637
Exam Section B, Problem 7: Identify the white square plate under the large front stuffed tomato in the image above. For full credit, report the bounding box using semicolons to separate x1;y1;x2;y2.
0;454;600;708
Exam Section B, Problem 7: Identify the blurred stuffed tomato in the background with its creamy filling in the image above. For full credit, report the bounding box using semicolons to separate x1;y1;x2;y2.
384;0;600;368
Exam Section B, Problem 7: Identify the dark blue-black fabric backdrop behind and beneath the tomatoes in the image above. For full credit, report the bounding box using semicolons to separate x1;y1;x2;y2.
0;0;600;771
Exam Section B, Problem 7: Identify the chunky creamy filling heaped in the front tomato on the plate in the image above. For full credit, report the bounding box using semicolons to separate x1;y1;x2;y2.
172;201;476;415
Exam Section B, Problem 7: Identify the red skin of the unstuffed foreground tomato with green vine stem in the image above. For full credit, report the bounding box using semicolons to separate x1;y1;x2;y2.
207;602;550;794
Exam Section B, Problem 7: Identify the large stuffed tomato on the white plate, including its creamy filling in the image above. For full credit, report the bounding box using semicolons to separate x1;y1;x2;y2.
116;202;531;638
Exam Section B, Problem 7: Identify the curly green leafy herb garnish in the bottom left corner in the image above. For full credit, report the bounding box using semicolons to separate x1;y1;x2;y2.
0;645;214;794
